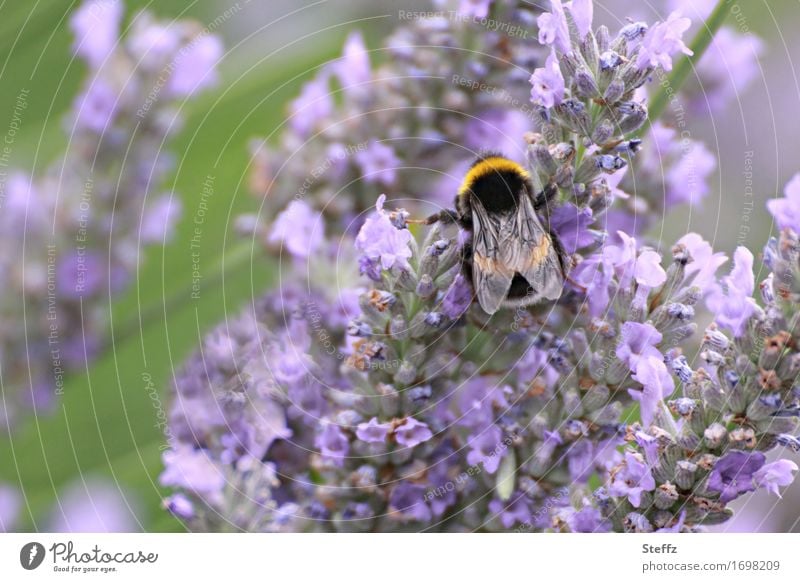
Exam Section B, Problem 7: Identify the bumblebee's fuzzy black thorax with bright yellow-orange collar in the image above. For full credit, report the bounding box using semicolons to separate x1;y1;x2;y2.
458;154;529;213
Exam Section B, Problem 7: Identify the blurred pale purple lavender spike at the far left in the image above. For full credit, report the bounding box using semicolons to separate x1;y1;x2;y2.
0;0;222;425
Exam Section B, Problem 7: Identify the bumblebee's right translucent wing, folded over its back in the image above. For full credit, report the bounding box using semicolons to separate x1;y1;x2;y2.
499;195;564;304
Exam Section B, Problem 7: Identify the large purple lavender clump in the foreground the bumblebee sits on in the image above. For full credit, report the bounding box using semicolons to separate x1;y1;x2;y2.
161;0;800;532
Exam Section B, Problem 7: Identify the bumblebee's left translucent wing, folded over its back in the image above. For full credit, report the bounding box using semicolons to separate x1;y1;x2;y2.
472;201;514;315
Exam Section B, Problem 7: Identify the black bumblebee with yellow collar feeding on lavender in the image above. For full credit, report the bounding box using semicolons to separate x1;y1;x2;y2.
427;153;570;315
